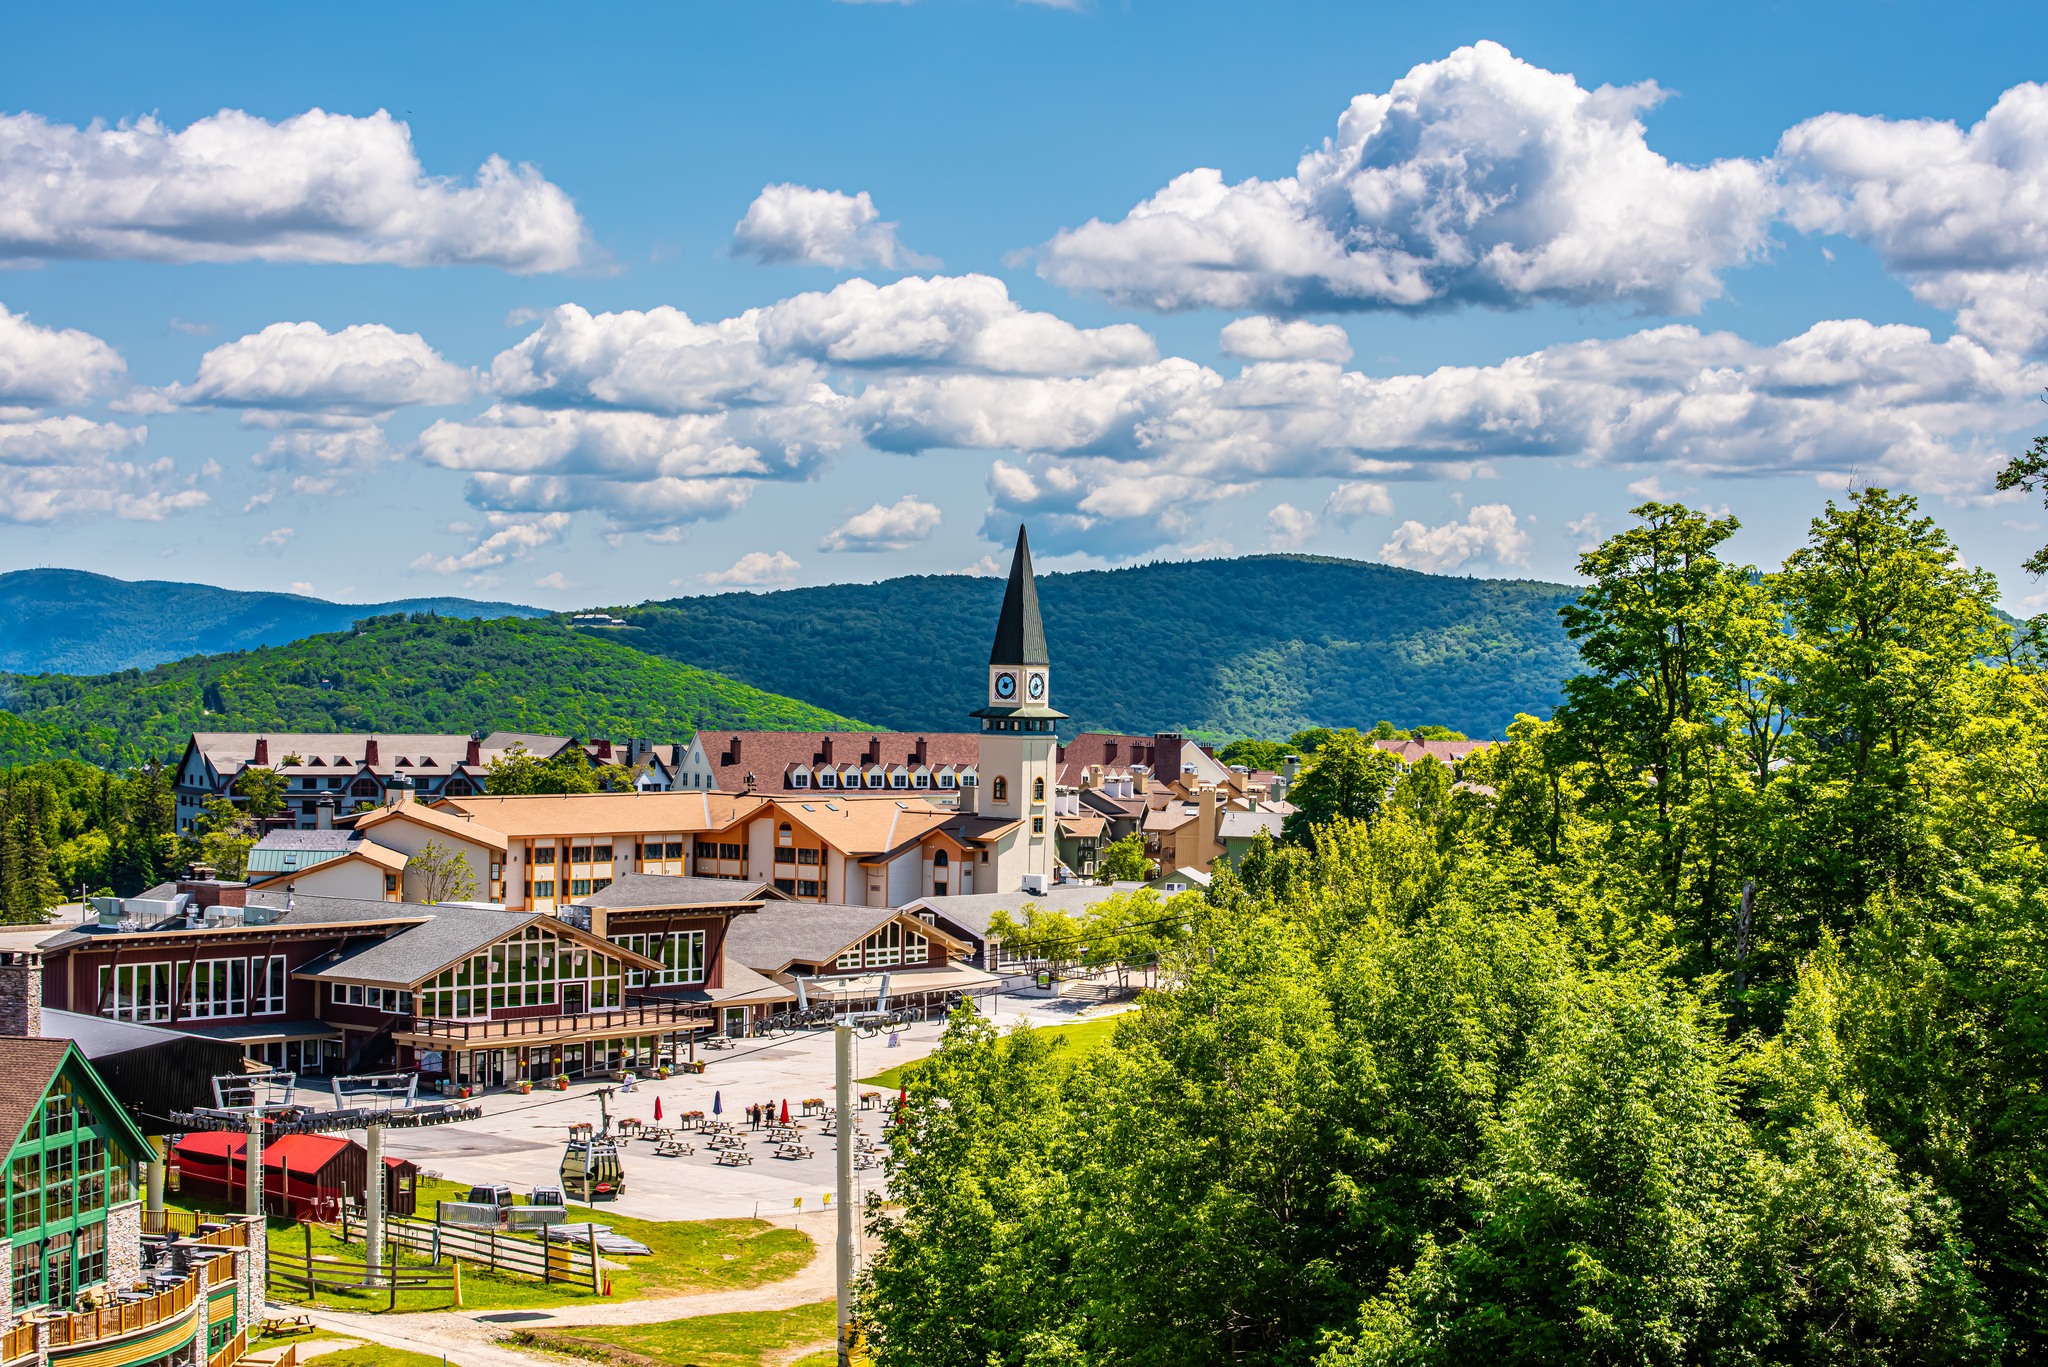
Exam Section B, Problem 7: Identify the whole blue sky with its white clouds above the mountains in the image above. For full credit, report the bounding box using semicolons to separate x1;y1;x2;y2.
0;0;2048;613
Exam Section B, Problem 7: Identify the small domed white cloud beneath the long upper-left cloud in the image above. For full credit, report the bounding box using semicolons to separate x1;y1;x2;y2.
154;322;475;426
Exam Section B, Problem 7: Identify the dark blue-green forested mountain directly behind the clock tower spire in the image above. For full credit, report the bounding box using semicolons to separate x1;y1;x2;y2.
608;555;1577;736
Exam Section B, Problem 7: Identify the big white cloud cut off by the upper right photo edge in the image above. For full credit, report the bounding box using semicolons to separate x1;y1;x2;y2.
1778;84;2048;350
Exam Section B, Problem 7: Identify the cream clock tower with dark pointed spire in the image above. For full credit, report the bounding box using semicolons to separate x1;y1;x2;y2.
971;527;1067;892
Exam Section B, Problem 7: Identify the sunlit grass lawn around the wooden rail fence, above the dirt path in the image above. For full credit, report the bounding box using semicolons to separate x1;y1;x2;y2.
166;1178;817;1310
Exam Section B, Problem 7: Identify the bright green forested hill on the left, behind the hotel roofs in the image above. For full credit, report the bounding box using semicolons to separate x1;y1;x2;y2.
0;615;860;764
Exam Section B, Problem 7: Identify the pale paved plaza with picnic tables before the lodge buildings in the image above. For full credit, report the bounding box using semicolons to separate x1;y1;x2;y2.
385;994;1114;1219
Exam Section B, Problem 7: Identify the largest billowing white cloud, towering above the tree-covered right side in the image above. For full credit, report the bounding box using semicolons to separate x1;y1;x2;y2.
1038;43;1774;314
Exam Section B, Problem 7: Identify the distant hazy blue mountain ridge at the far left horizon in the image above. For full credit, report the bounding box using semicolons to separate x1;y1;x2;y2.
0;570;545;674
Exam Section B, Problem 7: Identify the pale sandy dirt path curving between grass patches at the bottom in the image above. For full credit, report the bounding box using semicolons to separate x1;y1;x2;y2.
292;1213;836;1367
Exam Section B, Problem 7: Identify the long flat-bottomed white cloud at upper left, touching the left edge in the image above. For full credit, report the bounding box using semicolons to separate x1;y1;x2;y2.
0;109;584;273
